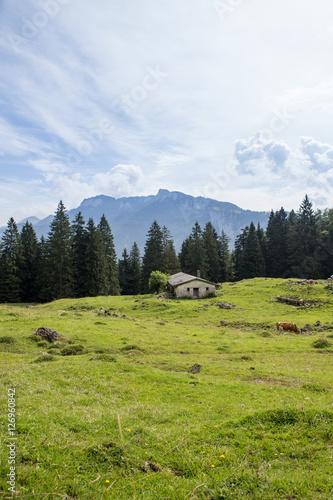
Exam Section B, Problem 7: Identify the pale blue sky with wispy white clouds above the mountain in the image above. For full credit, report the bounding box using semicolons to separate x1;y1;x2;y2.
0;0;333;225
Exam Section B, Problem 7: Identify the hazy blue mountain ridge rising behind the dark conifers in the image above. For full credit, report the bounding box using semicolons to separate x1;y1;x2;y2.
0;189;269;258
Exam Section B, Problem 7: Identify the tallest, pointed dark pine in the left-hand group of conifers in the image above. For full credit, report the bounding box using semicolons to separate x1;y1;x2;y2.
43;201;74;300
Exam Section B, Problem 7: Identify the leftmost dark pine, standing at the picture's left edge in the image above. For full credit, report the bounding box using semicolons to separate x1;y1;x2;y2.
0;218;22;302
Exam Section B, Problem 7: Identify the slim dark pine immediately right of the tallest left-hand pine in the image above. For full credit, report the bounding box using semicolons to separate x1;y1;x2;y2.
72;212;87;297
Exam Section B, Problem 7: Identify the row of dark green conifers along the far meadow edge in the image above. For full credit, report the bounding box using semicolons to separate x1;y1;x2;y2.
0;196;333;302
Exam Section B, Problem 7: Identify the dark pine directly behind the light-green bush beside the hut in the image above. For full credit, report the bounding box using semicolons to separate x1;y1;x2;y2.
142;220;164;293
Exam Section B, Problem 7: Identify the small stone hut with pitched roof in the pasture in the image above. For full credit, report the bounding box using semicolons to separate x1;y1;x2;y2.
168;271;218;299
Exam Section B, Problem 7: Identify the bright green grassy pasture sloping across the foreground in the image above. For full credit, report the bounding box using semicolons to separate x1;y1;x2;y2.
0;278;333;500
